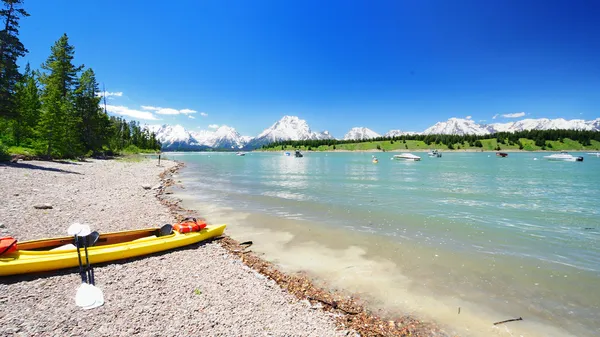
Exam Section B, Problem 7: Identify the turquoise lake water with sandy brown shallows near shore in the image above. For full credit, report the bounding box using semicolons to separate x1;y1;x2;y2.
166;152;600;336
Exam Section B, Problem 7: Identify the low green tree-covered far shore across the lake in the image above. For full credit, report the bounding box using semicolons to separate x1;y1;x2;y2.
261;130;600;151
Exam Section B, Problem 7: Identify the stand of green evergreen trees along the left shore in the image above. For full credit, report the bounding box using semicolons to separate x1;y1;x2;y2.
0;0;161;160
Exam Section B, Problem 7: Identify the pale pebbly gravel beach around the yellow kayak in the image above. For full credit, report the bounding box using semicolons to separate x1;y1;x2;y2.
0;160;356;336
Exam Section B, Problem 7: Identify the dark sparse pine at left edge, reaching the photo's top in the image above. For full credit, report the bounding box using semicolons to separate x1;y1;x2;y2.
0;0;29;117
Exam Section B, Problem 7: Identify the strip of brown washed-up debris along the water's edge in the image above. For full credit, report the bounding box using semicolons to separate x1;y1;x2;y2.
156;159;447;336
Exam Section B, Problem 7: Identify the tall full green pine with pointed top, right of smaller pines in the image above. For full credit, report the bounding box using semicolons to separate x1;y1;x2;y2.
38;34;83;157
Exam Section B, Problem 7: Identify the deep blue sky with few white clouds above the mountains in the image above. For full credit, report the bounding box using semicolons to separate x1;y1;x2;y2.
16;0;600;137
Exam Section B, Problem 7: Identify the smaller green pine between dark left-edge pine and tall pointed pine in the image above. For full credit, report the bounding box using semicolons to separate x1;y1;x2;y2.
11;63;40;146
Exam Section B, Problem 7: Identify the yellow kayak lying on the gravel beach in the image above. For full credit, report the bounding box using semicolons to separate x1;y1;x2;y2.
0;225;225;276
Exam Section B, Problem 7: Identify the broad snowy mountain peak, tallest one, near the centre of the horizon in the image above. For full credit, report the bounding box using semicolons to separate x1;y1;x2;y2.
247;116;333;148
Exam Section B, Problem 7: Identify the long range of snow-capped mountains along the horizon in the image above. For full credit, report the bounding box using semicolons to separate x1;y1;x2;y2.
146;116;600;151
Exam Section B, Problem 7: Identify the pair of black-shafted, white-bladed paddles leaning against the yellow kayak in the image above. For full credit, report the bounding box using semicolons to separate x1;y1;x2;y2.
67;223;104;310
